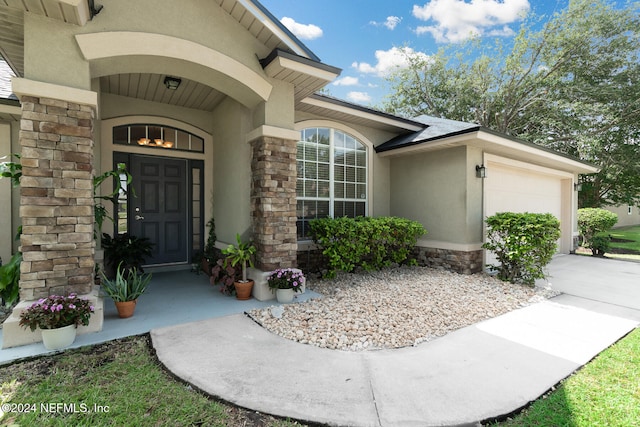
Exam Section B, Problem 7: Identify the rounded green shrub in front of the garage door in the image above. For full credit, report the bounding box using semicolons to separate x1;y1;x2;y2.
482;212;560;286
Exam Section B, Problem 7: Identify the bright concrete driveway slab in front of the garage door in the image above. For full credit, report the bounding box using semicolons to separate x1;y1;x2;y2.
538;255;640;320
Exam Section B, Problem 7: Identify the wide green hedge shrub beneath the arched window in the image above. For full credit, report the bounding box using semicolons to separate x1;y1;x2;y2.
310;217;427;277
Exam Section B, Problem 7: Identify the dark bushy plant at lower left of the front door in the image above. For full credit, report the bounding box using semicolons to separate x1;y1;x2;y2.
102;233;153;279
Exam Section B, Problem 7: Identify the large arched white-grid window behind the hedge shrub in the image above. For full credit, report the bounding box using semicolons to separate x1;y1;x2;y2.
296;128;368;239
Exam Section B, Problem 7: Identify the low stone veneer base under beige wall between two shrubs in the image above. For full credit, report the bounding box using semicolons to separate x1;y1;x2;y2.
414;246;483;274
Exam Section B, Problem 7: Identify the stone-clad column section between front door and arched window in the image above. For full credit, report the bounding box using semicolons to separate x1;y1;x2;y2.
251;136;298;271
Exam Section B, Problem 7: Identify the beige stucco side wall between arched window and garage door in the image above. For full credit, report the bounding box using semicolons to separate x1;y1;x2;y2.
390;147;481;246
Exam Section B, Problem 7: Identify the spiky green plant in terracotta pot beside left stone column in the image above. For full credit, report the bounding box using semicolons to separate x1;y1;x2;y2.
102;262;151;318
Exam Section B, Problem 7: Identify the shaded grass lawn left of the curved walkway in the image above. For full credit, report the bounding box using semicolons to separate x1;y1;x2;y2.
0;336;300;427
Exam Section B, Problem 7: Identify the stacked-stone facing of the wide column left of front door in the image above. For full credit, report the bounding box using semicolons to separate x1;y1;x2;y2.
20;96;95;300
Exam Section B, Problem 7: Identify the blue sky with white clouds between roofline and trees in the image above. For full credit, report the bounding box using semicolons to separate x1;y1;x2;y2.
259;0;604;106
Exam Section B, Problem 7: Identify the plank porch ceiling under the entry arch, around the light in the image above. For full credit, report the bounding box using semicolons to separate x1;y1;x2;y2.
100;73;226;111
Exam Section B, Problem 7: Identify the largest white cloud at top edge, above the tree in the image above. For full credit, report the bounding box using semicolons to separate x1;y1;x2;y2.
413;0;531;42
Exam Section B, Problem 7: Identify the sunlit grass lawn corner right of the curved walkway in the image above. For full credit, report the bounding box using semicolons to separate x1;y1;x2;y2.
498;329;640;427
